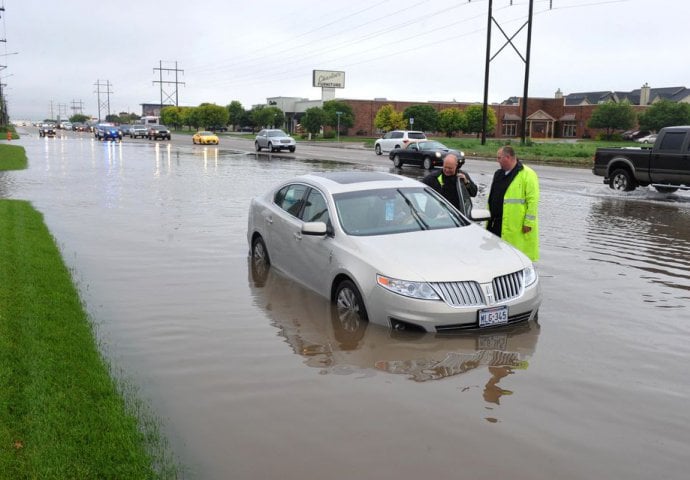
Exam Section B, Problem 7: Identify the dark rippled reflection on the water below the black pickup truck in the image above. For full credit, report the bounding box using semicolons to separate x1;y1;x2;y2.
585;198;690;292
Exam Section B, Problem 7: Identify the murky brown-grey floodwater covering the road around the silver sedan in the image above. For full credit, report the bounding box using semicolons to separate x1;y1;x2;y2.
0;136;690;480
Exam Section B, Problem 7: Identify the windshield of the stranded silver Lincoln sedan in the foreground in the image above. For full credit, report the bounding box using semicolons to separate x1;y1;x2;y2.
333;187;469;236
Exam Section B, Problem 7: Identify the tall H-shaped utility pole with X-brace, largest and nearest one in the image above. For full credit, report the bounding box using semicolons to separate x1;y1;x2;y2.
482;0;536;145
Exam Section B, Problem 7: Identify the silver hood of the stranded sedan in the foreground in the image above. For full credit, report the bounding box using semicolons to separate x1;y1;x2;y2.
350;224;530;283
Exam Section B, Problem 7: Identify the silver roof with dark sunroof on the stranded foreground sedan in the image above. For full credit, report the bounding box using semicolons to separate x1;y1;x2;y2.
290;171;423;194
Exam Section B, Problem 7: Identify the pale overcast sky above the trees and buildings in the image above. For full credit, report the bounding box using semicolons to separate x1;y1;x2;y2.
0;0;690;120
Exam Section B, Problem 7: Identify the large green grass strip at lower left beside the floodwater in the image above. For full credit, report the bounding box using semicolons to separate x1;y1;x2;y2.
0;200;176;479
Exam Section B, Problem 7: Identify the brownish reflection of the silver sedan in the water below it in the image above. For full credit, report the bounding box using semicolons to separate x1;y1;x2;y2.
249;259;539;392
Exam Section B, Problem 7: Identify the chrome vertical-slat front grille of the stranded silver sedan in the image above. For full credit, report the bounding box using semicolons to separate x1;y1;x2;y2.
431;271;523;307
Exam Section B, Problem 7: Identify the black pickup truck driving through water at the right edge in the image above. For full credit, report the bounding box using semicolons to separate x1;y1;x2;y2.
592;126;690;193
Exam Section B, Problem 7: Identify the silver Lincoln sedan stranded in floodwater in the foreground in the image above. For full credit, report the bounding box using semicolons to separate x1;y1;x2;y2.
247;172;541;333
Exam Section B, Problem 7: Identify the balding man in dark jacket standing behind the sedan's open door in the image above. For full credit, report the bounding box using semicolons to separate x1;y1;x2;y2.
422;153;477;216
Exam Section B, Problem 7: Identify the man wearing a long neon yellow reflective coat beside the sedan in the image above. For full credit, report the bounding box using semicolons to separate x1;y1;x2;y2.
487;145;539;261
